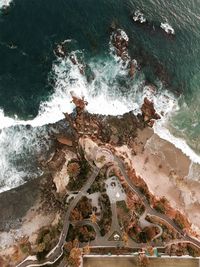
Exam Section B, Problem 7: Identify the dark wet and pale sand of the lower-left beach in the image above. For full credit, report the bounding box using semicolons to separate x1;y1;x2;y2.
0;176;56;256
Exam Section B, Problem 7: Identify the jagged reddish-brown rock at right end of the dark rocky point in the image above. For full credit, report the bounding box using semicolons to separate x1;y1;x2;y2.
141;97;161;125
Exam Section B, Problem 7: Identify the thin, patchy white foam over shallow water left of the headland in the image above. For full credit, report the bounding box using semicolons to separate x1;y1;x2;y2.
0;126;51;192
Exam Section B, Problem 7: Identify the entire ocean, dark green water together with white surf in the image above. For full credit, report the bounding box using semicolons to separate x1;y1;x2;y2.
0;0;200;192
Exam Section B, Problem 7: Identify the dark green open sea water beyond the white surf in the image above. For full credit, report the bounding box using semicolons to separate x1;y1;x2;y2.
0;0;200;193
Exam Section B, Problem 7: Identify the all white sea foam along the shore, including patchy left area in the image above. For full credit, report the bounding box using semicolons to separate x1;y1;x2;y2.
0;49;200;192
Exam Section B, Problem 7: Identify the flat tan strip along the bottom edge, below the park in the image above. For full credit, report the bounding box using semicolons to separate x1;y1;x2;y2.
83;256;199;267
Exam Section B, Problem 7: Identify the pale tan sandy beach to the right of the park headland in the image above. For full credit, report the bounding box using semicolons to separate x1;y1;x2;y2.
117;129;200;235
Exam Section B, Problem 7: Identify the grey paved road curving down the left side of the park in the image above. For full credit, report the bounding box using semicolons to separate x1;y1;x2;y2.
17;167;99;267
